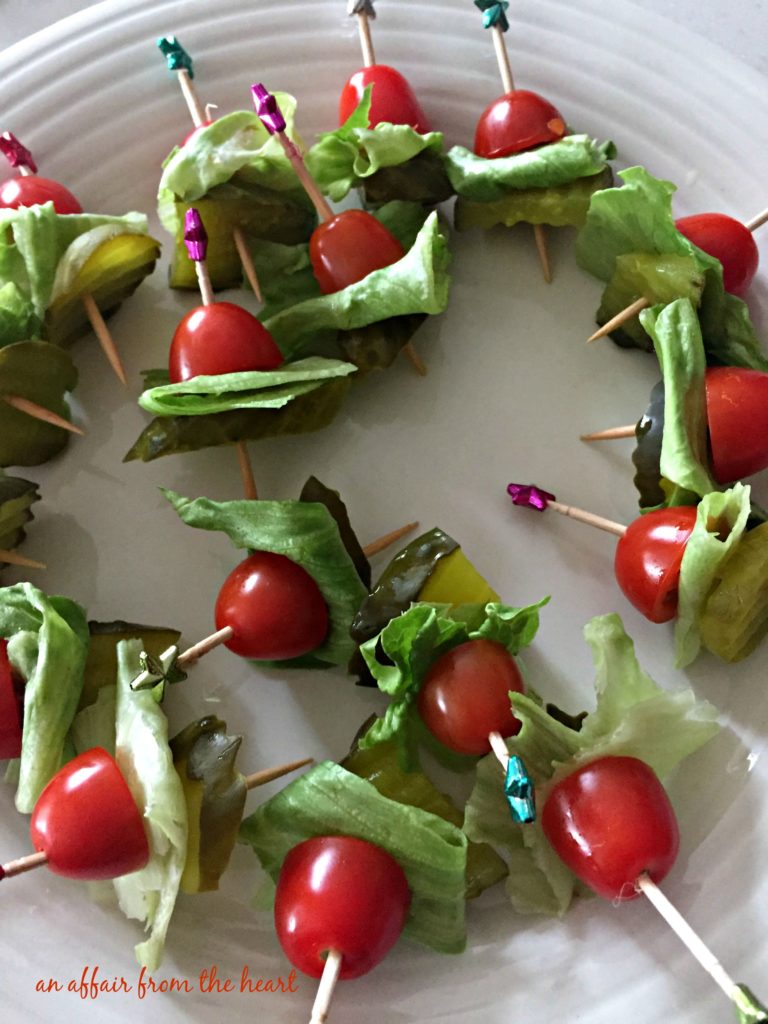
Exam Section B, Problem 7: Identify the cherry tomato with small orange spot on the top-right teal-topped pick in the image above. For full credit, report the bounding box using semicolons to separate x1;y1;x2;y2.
475;89;565;160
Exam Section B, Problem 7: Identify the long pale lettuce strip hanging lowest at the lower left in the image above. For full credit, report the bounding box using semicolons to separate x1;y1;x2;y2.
113;640;187;974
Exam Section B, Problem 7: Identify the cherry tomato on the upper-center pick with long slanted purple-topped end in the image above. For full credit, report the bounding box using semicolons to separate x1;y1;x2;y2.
309;210;404;295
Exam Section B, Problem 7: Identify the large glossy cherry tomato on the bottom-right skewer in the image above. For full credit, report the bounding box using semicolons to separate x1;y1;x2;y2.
542;757;680;900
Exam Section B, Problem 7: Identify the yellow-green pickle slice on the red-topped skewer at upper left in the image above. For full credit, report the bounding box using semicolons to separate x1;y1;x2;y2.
43;234;160;346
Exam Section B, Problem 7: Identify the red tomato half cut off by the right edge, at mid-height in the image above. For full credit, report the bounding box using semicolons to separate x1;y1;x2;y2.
705;367;768;483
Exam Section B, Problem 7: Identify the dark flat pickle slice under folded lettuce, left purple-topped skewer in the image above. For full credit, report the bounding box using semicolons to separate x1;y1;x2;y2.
123;377;350;462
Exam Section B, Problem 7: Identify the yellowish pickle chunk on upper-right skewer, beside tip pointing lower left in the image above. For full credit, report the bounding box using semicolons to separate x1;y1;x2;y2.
596;253;706;352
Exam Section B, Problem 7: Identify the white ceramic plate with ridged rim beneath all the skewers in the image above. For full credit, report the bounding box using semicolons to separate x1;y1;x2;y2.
0;0;768;1024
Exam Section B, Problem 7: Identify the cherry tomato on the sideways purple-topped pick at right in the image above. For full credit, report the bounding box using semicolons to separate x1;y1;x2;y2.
613;505;696;623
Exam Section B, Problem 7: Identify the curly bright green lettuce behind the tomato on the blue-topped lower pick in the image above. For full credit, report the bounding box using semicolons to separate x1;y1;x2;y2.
358;598;549;770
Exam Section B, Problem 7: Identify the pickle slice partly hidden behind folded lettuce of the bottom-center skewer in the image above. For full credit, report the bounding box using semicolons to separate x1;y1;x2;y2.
341;741;508;899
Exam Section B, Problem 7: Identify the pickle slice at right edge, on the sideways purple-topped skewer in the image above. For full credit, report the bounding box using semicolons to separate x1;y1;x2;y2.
698;523;768;662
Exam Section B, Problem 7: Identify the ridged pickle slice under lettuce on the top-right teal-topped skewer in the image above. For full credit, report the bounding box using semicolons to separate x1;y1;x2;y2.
454;167;613;231
